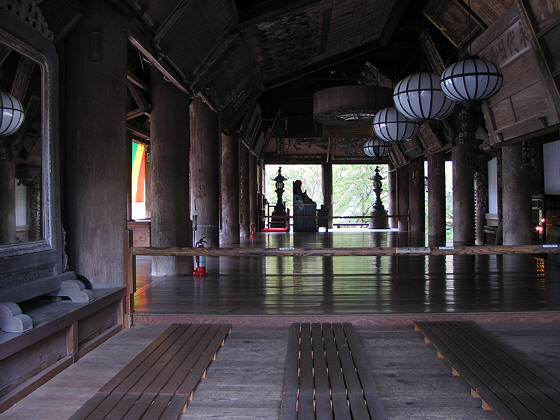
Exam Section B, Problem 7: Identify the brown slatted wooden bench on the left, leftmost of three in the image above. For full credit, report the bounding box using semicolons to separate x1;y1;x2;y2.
70;324;231;420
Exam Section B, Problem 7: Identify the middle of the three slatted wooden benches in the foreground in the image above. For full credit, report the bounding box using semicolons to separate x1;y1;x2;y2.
280;323;387;420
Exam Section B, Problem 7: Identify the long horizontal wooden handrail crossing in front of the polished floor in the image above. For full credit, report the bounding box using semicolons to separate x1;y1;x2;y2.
132;245;560;257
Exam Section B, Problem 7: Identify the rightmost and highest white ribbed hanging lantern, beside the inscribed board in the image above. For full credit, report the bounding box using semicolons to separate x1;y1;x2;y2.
440;56;504;102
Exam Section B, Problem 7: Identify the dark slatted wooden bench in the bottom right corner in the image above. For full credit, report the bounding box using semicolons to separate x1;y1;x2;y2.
415;322;560;420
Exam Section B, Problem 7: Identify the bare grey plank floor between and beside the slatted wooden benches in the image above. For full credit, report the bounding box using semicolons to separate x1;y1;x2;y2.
0;323;560;420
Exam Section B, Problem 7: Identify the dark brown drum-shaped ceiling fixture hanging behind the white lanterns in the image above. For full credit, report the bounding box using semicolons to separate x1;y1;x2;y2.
313;85;391;127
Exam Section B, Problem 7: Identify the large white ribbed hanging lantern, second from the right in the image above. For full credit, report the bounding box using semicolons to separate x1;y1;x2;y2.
393;72;455;121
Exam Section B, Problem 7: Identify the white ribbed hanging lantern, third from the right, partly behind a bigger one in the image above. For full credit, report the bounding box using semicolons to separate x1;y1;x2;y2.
373;107;421;142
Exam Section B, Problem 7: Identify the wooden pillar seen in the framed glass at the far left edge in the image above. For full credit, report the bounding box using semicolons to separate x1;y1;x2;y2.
0;153;16;245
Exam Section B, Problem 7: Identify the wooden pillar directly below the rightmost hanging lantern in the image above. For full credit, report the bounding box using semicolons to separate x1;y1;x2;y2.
451;143;474;245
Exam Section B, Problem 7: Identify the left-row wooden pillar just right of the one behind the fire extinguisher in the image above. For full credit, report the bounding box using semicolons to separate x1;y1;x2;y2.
220;130;239;245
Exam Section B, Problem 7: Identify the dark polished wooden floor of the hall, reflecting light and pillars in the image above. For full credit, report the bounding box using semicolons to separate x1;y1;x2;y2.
130;229;560;325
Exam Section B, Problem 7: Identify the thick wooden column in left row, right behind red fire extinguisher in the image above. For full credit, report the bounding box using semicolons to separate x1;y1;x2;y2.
191;97;220;247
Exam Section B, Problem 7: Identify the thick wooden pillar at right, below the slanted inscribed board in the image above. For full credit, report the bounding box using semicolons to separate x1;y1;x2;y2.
502;143;531;245
